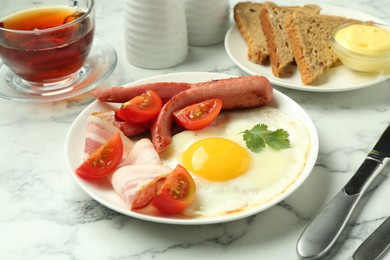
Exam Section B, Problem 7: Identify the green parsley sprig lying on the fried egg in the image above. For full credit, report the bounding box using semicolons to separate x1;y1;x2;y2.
243;124;290;153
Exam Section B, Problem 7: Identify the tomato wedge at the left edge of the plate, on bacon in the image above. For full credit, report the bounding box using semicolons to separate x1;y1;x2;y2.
76;132;123;180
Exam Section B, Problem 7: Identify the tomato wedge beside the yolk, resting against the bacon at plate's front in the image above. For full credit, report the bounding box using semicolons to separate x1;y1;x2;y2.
151;165;196;214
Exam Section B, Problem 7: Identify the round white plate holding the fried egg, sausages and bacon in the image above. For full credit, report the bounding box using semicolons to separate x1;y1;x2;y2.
65;72;318;225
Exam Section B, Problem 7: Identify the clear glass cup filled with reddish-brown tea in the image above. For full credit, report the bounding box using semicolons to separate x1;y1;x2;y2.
0;0;95;94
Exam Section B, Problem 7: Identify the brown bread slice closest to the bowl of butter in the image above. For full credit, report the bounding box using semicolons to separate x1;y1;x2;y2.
285;12;360;85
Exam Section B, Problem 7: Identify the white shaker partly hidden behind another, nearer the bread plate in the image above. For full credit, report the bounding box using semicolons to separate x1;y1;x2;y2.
184;0;229;46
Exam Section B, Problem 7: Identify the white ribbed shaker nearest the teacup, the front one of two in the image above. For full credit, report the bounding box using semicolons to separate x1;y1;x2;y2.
124;0;188;69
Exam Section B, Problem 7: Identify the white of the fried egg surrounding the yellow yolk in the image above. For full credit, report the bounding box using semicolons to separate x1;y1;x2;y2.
161;107;310;217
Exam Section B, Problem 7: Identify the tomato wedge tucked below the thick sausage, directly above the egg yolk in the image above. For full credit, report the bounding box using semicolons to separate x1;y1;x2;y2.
173;98;222;130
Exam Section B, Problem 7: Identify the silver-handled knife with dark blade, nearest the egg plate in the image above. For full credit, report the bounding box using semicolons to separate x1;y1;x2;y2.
297;125;390;259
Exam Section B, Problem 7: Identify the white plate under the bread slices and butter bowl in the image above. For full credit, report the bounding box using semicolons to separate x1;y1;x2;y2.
225;5;390;92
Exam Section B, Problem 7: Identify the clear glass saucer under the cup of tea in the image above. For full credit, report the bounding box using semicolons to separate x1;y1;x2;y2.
0;37;117;103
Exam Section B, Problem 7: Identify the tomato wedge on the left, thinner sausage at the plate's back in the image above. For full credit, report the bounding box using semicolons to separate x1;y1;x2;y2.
118;90;162;124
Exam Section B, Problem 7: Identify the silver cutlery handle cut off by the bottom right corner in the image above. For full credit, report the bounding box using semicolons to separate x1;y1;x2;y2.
353;217;390;260
